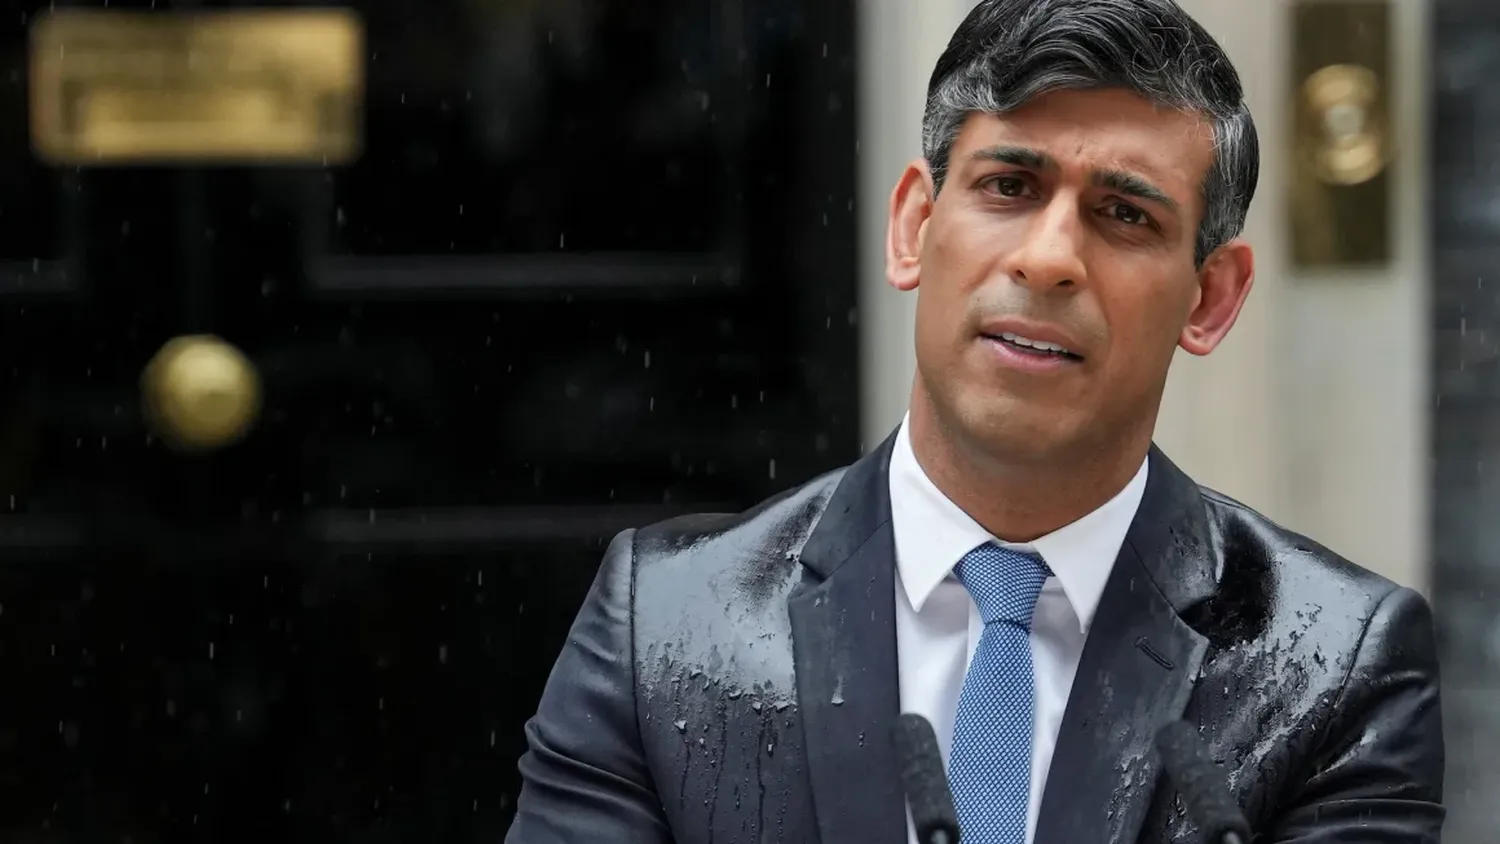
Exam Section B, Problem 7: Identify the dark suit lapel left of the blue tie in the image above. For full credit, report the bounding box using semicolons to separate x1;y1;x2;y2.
788;438;906;844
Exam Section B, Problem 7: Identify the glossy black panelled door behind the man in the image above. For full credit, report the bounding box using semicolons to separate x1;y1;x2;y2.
0;0;858;843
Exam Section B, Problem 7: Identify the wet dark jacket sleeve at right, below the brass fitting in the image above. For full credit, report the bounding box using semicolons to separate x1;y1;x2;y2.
1271;589;1445;844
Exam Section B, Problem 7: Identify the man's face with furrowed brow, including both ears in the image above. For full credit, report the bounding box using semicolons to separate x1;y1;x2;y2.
888;90;1251;460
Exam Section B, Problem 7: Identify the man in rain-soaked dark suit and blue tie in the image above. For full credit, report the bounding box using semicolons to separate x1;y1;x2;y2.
507;0;1443;844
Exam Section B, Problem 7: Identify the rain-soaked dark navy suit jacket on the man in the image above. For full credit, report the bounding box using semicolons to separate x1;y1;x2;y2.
506;442;1443;844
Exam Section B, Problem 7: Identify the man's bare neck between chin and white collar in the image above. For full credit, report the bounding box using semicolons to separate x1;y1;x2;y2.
911;403;1151;543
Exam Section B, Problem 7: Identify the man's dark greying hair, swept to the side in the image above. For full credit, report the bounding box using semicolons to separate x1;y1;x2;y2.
923;0;1260;265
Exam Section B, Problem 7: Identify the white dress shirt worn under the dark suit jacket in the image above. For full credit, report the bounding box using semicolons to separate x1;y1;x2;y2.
891;421;1146;844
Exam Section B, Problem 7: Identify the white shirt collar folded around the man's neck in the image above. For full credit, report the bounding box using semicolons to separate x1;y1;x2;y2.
890;418;1149;633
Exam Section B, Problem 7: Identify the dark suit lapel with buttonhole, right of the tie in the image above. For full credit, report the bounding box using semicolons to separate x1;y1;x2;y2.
1035;448;1223;844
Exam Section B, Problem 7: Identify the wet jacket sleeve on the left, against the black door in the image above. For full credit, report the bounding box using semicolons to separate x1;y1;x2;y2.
506;531;672;844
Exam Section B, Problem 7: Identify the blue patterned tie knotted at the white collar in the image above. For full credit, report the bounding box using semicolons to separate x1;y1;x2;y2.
948;544;1050;844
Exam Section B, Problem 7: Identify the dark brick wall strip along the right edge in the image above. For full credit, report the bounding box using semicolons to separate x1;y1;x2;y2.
1428;0;1500;843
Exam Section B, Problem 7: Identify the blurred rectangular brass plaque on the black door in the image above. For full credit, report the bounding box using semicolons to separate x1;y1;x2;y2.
30;9;365;166
